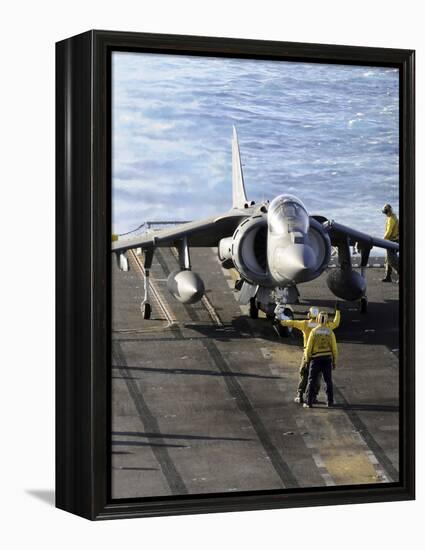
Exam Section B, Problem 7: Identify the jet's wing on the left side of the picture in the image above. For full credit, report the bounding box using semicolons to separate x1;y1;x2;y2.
112;209;251;252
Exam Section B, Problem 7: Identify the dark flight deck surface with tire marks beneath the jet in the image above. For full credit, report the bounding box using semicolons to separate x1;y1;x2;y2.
111;248;399;498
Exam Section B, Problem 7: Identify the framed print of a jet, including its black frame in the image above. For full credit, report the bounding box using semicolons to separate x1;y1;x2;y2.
56;31;414;519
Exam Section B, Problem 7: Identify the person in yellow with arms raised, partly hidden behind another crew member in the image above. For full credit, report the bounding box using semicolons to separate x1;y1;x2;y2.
280;302;341;404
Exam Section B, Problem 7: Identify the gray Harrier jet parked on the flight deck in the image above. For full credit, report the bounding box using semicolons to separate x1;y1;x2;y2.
112;128;399;336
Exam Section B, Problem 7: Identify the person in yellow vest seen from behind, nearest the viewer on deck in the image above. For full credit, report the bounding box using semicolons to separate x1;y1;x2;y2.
304;311;338;408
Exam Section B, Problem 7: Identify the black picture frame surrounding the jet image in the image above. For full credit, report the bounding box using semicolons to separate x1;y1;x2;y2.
56;31;415;520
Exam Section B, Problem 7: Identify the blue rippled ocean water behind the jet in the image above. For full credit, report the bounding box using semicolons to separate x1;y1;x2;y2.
112;52;399;249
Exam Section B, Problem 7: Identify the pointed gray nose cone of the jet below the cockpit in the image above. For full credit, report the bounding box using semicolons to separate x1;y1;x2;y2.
276;244;316;282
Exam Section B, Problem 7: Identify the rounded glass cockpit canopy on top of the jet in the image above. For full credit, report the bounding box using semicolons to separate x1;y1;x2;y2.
267;195;310;235
